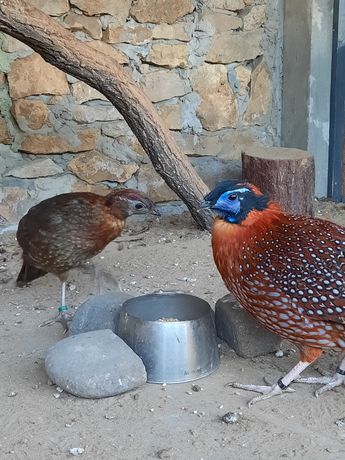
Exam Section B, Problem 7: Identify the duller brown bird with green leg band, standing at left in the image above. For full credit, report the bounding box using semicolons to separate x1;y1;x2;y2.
17;189;159;329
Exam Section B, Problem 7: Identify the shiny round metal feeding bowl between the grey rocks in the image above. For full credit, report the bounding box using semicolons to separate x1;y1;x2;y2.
117;292;219;383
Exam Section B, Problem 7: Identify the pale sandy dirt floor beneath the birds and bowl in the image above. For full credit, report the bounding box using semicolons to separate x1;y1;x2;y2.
0;202;345;460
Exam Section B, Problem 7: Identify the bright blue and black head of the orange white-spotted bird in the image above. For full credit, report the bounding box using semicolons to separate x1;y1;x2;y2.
201;180;269;224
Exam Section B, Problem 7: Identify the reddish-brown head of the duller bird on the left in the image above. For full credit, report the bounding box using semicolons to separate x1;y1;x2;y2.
106;188;160;218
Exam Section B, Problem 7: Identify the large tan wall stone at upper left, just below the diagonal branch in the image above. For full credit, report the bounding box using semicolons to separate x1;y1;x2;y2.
7;53;69;99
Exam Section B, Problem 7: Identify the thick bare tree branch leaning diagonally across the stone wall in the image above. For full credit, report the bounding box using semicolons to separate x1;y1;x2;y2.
0;0;212;229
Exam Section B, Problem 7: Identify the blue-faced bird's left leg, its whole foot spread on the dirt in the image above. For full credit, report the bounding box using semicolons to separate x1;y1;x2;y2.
228;347;323;406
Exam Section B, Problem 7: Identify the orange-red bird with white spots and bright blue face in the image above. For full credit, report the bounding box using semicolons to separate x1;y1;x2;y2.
202;181;345;404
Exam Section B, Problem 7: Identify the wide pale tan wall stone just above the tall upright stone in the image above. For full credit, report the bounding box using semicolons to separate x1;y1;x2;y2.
205;30;263;64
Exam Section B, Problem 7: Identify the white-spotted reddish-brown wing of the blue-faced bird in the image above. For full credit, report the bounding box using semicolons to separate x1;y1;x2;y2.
258;216;345;324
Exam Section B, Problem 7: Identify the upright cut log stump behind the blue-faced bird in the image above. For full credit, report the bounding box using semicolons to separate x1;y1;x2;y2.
242;147;315;216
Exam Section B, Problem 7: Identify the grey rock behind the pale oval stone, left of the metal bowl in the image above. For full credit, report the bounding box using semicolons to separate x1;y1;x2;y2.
69;291;132;335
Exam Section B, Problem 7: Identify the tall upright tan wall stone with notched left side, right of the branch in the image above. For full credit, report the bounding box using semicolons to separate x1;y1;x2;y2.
191;64;238;131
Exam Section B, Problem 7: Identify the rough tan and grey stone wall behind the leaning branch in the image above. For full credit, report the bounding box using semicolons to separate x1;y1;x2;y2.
0;0;282;221
